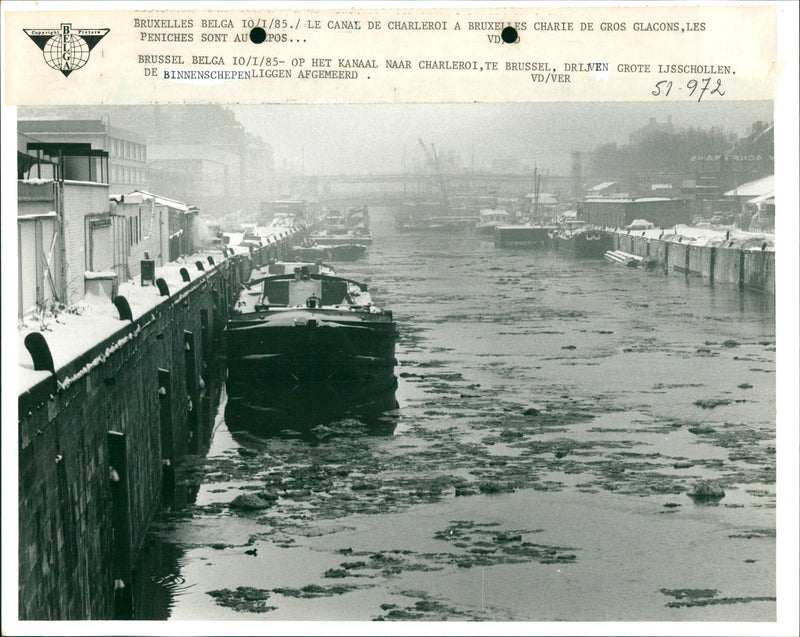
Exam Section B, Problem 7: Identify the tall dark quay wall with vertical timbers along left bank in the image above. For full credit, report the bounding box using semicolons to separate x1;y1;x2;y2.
18;231;297;620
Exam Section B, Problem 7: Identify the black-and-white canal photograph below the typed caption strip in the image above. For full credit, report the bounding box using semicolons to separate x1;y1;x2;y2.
12;100;780;620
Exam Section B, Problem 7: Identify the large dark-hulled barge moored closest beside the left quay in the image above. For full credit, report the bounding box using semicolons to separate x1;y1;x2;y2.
226;264;397;428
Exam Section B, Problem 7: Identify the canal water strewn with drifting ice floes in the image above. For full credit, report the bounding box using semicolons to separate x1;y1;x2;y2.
136;209;776;622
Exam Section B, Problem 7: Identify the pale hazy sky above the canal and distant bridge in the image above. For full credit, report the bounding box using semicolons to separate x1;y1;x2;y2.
232;101;773;174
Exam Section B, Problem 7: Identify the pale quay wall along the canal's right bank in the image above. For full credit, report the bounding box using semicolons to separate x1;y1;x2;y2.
613;232;775;295
